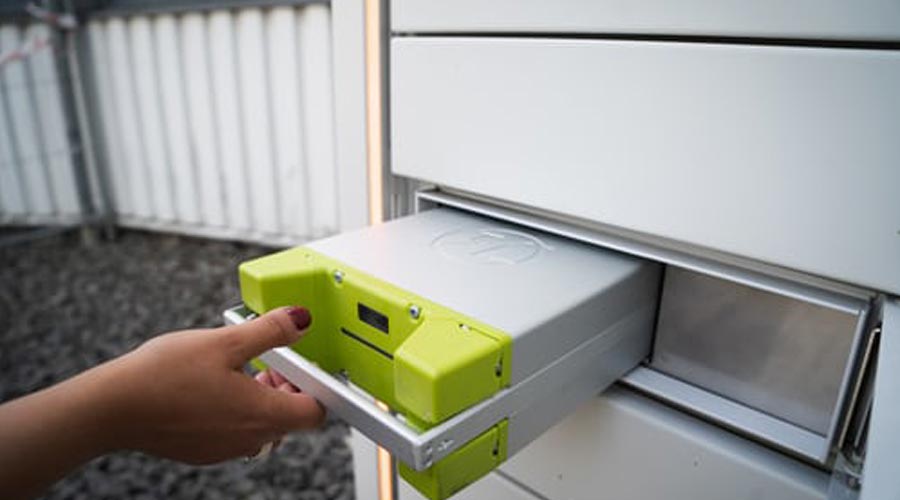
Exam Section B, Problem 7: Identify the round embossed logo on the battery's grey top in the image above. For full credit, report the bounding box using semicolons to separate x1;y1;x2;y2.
431;228;553;265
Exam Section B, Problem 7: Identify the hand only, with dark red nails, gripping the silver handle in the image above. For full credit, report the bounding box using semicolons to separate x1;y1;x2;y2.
97;307;325;464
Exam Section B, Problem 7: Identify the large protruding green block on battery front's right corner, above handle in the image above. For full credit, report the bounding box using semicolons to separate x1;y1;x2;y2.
394;318;503;425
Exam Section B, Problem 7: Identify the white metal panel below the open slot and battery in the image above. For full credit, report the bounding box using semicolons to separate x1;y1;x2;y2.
500;388;828;500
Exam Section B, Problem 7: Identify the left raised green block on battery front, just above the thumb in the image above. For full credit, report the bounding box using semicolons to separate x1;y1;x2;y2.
238;247;321;314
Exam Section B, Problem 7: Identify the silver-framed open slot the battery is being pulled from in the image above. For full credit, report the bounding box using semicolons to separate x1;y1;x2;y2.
418;190;880;467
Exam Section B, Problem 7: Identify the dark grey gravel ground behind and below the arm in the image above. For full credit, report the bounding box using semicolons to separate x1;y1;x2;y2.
0;231;353;500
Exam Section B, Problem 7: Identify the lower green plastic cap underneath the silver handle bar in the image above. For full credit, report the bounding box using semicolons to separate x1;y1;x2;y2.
399;420;507;500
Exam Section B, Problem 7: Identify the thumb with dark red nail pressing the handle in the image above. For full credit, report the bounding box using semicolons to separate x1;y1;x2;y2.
226;306;312;367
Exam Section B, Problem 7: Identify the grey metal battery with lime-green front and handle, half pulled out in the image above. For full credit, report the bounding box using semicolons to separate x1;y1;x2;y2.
225;208;660;499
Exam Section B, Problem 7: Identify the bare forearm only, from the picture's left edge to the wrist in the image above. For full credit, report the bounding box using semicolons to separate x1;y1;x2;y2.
0;366;112;499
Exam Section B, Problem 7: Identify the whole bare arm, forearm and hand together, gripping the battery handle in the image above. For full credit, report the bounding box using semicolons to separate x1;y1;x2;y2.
0;307;325;499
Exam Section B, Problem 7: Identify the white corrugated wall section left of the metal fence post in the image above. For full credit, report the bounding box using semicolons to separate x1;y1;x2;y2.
0;24;81;225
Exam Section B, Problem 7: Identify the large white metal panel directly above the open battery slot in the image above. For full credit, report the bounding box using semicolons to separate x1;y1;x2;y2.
391;41;900;292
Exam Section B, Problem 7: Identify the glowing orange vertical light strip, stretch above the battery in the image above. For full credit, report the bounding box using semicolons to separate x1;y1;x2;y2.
365;0;384;224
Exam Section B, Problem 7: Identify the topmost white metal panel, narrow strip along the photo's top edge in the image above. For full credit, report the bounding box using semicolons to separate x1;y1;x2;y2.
391;0;900;40
